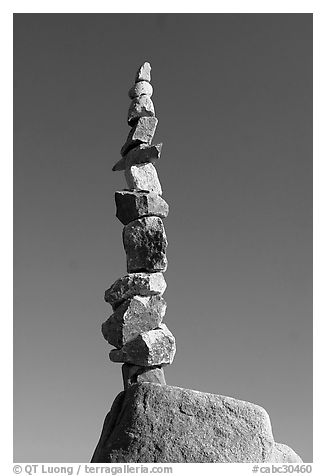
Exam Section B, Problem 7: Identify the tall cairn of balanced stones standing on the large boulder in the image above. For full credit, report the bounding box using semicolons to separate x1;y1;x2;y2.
102;62;176;389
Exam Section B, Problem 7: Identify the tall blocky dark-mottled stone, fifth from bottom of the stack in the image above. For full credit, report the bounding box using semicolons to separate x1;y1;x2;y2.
123;217;168;273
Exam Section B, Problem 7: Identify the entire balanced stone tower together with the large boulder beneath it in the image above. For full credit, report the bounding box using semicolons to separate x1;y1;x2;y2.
91;63;302;464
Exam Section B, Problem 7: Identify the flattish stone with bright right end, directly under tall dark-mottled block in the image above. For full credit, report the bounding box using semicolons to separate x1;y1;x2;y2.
104;273;166;310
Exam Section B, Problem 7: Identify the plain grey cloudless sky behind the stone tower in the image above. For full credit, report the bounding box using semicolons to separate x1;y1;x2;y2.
14;14;312;462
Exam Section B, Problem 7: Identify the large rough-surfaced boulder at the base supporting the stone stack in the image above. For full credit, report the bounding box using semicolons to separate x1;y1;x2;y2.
92;383;301;463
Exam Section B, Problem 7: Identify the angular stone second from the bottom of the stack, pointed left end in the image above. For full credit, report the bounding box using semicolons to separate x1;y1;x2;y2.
109;324;176;367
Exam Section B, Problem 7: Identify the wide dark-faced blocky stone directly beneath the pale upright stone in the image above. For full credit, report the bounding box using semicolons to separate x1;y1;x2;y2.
114;191;169;225
